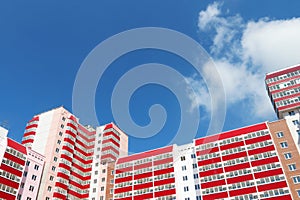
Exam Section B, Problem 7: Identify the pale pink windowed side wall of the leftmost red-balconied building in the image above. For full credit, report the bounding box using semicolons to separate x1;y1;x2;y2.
18;149;45;200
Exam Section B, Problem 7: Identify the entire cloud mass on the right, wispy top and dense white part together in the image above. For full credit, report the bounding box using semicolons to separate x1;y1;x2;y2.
187;3;300;119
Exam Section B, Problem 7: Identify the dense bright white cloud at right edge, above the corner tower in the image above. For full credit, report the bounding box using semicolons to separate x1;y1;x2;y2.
241;18;300;72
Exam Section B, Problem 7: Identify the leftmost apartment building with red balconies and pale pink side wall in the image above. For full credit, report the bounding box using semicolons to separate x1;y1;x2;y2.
0;127;44;200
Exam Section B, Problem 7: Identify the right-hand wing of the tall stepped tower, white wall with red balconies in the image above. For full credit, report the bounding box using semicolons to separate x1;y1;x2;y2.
89;123;128;200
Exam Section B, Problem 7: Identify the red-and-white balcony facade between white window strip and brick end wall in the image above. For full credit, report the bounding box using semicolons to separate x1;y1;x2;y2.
195;123;291;200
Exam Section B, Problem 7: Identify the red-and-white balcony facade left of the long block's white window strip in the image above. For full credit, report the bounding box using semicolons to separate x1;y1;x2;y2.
114;146;176;200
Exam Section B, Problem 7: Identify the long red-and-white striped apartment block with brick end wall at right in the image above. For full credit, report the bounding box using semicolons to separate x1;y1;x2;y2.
114;120;300;200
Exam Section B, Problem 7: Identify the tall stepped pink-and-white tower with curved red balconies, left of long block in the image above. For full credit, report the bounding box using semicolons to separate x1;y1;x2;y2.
22;107;128;200
